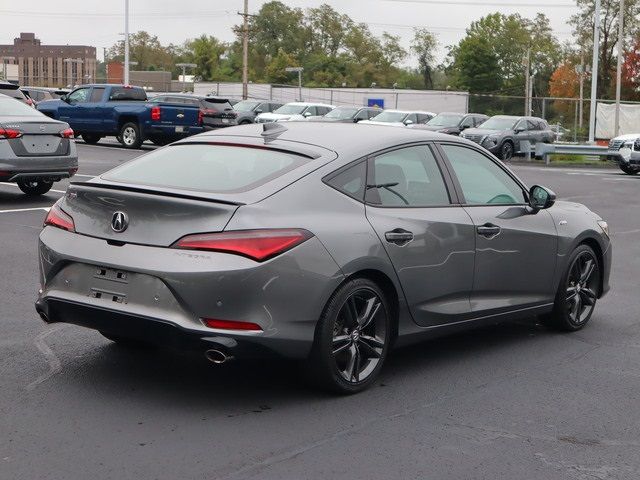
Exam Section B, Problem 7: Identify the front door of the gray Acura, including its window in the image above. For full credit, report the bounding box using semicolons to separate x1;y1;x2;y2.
440;143;558;314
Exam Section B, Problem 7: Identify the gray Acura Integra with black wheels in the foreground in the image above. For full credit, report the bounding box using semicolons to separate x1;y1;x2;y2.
36;122;611;393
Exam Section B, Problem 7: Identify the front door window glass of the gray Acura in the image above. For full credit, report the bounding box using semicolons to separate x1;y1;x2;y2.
442;145;525;205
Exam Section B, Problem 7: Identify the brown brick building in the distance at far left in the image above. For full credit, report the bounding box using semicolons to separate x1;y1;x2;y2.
0;33;96;87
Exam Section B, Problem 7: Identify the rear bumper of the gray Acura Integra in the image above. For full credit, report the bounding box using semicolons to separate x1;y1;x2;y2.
36;227;343;358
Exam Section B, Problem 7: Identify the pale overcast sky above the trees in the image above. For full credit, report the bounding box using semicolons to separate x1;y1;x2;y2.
0;0;576;63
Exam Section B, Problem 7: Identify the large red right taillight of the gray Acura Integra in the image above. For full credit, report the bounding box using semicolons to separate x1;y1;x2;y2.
172;229;313;262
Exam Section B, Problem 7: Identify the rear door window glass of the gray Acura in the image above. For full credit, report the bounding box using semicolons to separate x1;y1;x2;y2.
365;145;451;207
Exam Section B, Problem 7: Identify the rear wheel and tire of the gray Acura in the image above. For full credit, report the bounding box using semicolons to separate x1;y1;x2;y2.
308;278;391;394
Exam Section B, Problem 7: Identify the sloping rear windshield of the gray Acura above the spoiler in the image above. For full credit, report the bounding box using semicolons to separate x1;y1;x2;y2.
102;144;306;193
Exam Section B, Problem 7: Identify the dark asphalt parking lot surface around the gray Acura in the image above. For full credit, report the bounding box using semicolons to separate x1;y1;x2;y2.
0;144;640;480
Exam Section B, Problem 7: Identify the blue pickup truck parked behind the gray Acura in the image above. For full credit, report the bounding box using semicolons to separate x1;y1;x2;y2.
38;84;203;148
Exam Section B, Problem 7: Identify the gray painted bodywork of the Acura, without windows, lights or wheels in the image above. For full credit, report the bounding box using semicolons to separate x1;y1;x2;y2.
37;122;611;358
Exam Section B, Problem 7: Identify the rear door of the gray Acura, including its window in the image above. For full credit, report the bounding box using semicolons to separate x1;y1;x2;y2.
365;145;475;327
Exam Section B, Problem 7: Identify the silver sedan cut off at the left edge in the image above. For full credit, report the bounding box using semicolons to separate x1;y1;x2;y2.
0;95;78;195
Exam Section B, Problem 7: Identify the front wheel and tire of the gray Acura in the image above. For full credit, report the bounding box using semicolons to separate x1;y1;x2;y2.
541;245;600;332
